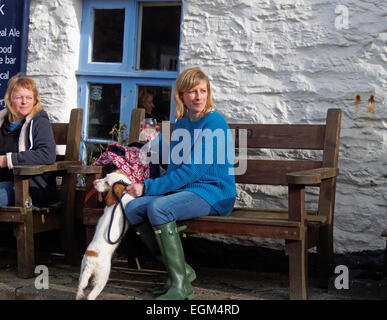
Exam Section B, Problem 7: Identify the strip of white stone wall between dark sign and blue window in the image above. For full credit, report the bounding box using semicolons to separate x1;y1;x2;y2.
27;0;82;122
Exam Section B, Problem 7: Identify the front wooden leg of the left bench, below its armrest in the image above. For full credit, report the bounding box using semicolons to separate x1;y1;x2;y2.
14;213;35;279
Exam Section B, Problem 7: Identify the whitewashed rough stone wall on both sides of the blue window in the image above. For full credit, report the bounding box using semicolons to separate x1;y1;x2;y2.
28;0;387;253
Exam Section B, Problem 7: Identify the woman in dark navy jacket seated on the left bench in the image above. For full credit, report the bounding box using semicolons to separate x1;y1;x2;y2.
0;74;57;206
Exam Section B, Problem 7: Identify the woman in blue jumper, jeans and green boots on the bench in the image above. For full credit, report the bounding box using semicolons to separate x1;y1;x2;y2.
125;68;236;300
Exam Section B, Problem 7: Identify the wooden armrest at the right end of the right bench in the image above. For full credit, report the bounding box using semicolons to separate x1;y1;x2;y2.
286;168;339;185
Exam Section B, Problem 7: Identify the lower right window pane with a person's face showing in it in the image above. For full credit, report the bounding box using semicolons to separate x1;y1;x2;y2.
137;86;171;122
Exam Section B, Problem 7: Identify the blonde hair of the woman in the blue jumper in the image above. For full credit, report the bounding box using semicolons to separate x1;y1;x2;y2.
174;67;214;119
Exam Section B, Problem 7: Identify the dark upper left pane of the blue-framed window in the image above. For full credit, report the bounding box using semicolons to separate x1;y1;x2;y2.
92;9;125;62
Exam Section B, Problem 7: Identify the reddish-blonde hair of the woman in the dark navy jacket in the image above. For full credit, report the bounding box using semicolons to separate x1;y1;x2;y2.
4;73;43;121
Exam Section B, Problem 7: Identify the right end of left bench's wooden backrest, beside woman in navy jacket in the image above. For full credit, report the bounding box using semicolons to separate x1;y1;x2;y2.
52;109;83;161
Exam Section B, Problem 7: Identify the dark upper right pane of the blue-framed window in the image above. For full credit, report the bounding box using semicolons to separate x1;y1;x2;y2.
137;4;180;71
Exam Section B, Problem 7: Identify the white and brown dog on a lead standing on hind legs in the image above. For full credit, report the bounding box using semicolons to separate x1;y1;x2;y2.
76;170;134;300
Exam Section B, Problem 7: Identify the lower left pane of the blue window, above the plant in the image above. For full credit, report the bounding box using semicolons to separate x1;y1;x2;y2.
87;83;121;140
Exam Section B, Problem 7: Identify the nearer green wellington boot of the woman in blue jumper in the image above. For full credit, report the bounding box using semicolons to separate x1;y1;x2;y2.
153;221;194;300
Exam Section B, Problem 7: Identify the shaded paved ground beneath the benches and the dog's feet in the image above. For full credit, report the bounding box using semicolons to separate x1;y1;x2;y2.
0;248;387;303
